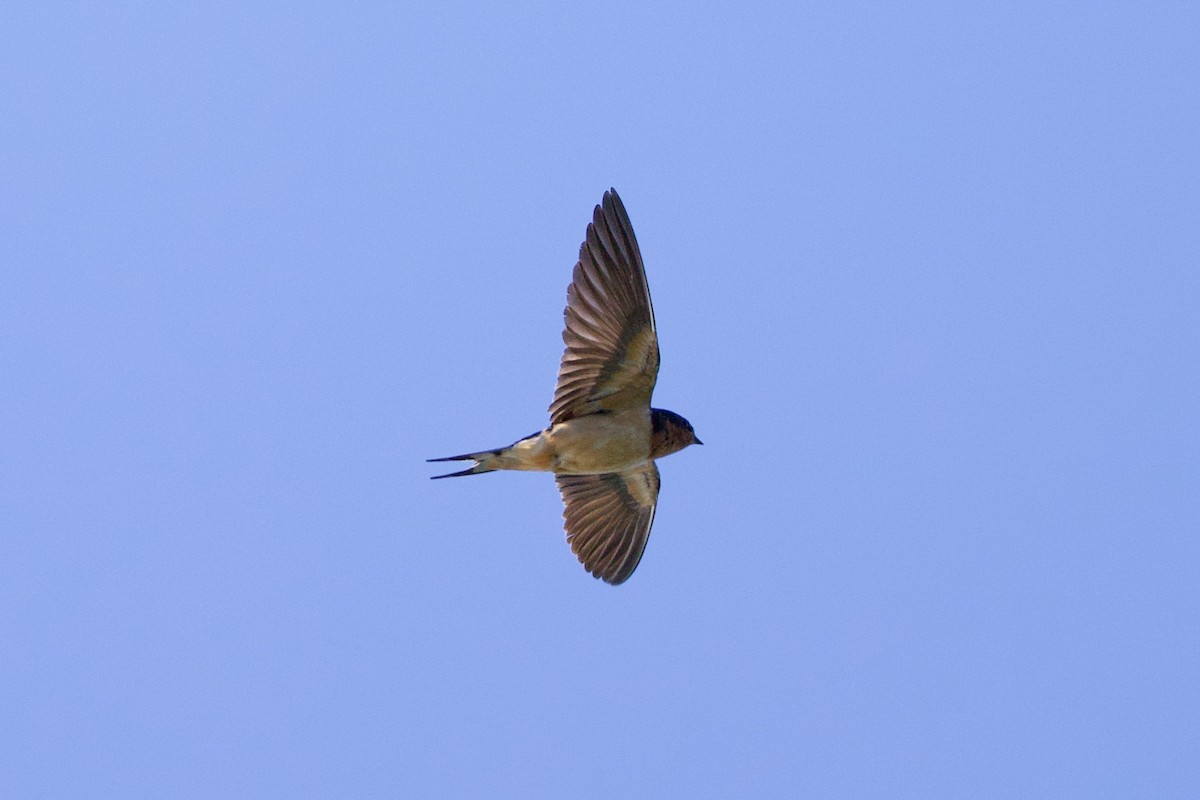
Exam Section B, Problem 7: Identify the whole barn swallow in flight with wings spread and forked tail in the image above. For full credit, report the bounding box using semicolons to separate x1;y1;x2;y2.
430;190;703;585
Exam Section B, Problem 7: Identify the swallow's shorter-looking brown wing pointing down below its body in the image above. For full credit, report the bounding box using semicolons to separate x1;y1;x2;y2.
556;461;659;585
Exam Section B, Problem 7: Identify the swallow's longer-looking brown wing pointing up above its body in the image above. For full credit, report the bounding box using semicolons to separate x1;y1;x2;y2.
550;190;659;422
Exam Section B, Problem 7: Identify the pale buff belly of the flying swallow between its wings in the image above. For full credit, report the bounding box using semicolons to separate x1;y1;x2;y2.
547;410;650;475
